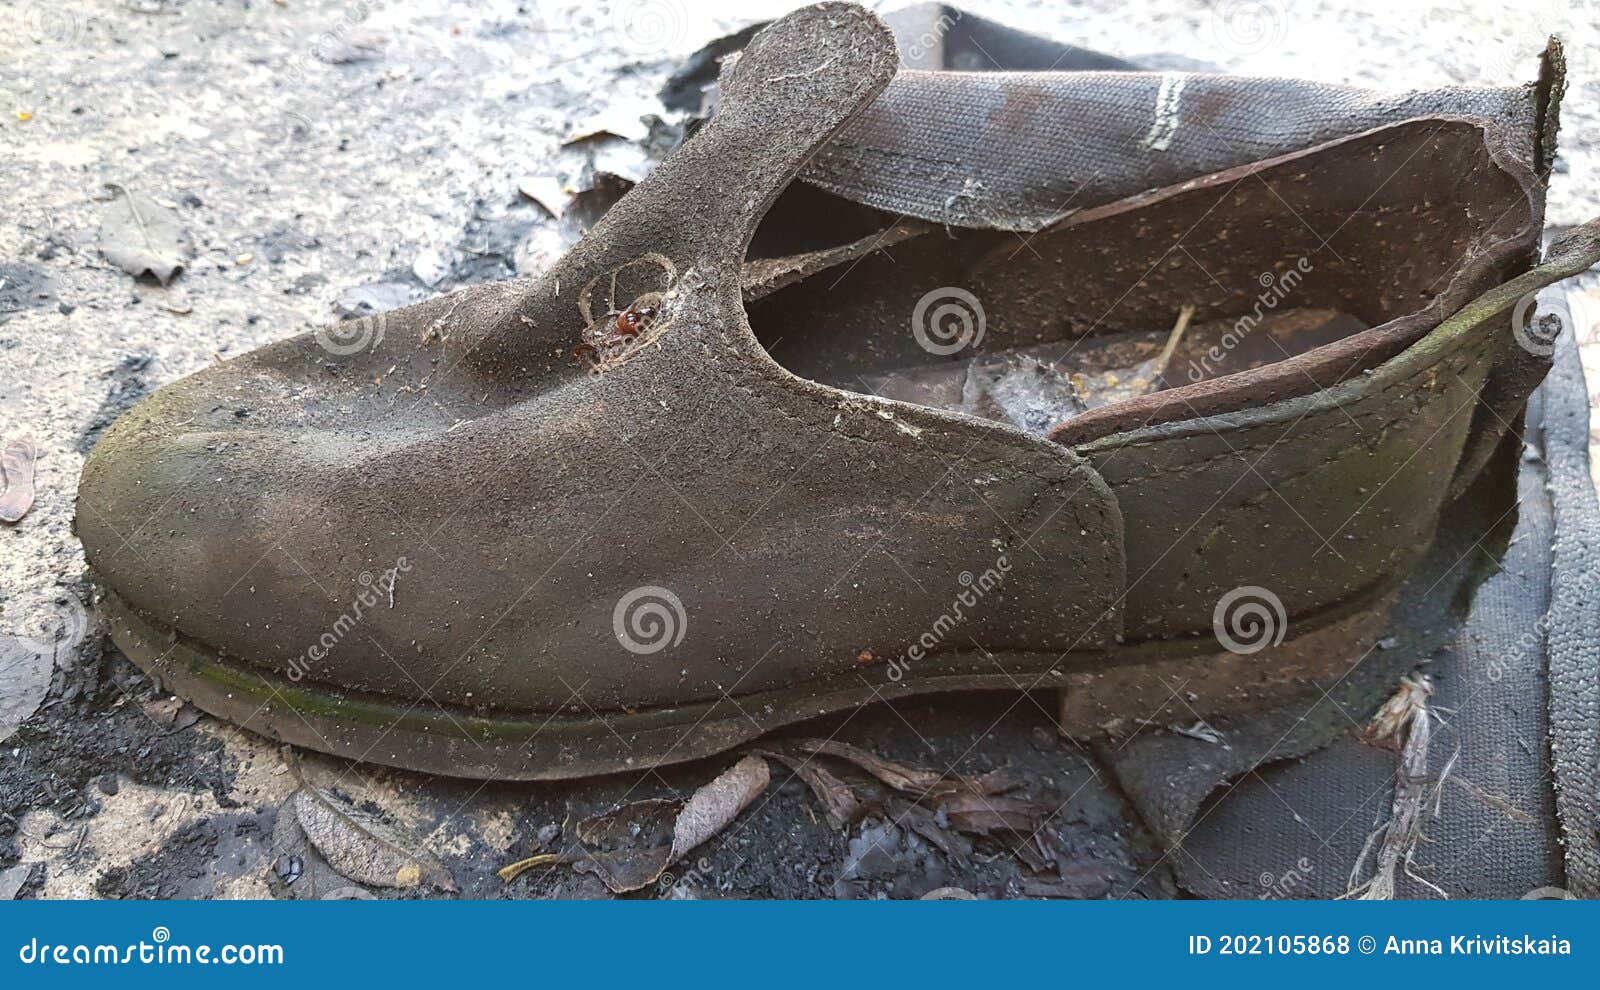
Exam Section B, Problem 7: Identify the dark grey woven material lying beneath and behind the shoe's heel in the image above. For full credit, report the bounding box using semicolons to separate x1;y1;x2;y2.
1114;323;1600;899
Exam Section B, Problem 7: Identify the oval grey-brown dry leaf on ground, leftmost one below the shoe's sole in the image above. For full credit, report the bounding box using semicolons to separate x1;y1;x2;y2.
290;785;456;891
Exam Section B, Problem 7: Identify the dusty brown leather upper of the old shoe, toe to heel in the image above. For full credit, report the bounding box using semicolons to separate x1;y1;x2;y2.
77;3;1594;712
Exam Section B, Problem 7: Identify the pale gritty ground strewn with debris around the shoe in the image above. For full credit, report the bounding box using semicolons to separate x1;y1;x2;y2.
0;0;1600;899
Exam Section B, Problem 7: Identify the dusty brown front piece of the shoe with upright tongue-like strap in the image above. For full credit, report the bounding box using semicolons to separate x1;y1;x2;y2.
78;5;1123;710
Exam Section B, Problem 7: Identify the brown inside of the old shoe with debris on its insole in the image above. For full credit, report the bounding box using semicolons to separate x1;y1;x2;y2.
746;118;1534;441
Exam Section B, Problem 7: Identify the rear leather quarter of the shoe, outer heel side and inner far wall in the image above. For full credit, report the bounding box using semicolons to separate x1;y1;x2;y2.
752;120;1565;638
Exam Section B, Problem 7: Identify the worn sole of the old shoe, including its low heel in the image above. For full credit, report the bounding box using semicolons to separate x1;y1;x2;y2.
99;590;1392;780
